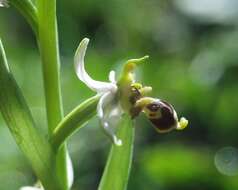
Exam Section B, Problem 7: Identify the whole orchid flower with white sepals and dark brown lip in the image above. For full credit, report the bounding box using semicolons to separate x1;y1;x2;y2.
74;38;188;146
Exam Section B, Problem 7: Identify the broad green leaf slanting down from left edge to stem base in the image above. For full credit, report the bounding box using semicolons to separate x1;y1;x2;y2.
0;40;60;190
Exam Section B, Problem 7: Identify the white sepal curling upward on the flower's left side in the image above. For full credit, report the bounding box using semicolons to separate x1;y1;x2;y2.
74;38;117;93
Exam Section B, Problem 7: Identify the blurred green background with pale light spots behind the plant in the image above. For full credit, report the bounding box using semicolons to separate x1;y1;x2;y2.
0;0;238;190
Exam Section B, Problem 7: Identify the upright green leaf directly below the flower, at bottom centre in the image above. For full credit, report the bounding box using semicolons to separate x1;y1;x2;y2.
98;114;135;190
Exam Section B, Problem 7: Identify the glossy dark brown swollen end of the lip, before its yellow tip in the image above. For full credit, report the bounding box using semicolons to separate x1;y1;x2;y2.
150;101;176;132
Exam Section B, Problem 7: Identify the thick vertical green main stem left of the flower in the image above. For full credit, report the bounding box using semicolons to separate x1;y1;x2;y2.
37;0;68;190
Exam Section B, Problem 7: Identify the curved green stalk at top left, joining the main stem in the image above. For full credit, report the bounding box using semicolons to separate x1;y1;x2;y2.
9;0;38;33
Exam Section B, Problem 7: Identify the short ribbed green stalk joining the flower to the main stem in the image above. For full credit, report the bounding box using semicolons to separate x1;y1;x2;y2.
51;96;100;150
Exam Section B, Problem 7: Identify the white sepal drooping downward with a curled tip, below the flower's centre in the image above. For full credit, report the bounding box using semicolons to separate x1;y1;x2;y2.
97;92;122;146
